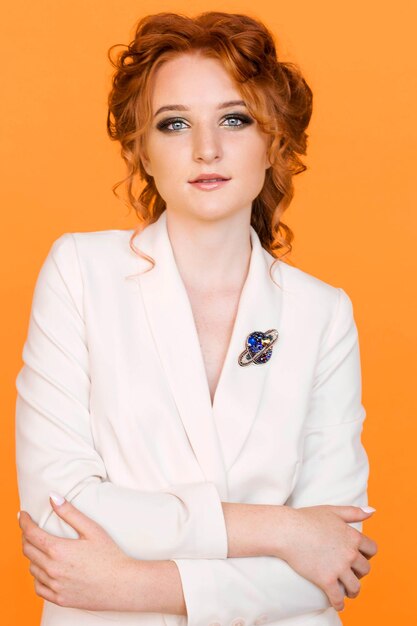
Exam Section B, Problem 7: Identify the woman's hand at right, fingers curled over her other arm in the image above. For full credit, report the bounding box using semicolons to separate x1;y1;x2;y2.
275;505;378;611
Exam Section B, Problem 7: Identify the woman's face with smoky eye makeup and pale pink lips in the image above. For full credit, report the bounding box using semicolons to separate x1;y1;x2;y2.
142;54;270;220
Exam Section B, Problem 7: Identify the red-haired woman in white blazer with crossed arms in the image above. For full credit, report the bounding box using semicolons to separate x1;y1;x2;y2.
16;12;377;626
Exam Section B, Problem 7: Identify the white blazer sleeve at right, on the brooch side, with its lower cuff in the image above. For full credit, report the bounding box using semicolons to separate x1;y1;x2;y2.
172;288;369;626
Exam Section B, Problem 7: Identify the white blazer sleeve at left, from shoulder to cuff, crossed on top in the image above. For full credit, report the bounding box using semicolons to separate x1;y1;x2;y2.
15;233;227;559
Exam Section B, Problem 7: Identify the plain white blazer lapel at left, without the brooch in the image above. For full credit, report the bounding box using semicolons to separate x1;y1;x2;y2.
129;212;227;499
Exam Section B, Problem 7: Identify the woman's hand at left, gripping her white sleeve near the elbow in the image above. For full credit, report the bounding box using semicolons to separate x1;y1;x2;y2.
19;490;138;610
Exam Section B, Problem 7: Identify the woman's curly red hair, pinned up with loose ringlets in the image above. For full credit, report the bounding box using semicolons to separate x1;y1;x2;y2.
107;11;312;270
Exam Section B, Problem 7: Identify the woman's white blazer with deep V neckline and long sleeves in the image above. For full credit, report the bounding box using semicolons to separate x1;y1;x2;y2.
16;213;369;626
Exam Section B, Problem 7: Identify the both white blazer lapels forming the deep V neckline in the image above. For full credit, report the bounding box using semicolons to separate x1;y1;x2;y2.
127;212;281;488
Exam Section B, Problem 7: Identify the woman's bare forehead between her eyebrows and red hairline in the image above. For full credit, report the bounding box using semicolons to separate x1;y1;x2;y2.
151;53;241;111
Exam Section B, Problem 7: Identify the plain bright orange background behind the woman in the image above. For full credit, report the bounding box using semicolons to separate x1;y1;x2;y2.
0;0;417;626
